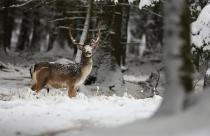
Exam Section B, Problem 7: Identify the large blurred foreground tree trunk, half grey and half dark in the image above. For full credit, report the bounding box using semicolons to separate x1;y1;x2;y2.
155;0;192;116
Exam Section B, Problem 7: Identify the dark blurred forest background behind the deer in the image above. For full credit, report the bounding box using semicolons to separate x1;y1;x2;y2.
0;0;209;98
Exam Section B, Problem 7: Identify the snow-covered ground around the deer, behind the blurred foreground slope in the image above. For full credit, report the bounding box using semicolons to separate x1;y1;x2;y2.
0;65;162;136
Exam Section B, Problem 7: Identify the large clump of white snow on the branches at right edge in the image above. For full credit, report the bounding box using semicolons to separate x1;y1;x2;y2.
192;4;210;50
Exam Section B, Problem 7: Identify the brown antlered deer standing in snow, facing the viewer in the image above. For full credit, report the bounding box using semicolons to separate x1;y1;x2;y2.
30;27;100;98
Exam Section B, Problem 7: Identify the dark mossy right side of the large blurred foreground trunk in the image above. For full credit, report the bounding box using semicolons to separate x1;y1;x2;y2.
180;0;194;94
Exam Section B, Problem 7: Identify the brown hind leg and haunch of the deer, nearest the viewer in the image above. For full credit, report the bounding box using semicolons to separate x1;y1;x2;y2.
31;67;49;93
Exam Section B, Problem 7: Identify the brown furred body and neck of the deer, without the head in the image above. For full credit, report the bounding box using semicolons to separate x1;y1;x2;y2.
31;51;92;97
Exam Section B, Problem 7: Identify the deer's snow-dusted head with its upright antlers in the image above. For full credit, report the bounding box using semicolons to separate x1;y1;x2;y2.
69;27;100;58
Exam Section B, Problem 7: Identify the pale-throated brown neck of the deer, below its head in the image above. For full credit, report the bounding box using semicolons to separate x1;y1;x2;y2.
80;55;93;78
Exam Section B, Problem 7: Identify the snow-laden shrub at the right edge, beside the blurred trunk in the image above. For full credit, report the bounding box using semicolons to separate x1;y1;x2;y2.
191;5;210;69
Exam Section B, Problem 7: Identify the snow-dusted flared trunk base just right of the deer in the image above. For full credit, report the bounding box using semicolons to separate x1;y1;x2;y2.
90;45;126;96
